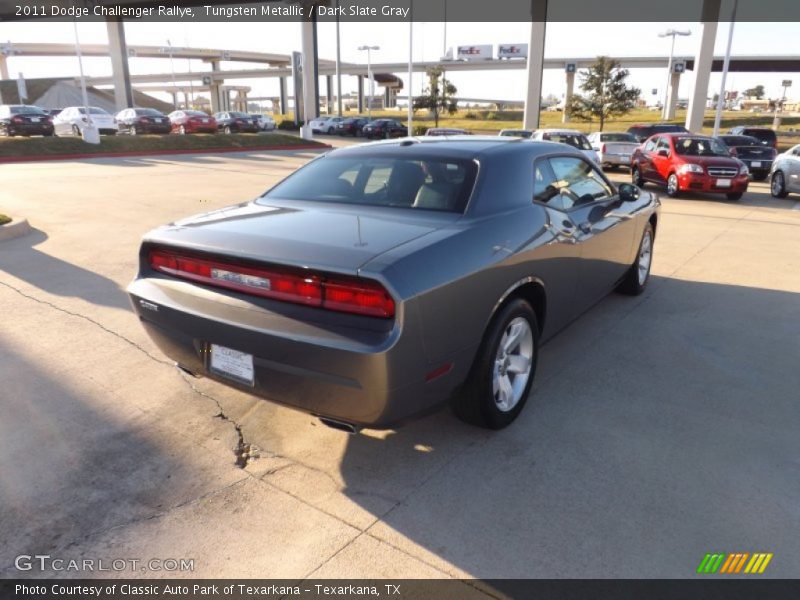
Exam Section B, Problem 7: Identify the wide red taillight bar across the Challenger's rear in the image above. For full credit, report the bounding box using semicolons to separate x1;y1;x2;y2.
149;250;395;318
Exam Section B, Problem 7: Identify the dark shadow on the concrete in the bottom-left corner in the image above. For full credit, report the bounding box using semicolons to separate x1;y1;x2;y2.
0;340;216;578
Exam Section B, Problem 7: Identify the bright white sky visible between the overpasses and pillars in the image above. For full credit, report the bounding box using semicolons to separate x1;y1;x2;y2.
0;22;800;108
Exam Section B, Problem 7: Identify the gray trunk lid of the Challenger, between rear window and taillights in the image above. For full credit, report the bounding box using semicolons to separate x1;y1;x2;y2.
145;202;461;274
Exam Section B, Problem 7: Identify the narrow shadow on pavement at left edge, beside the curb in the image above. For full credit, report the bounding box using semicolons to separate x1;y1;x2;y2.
0;229;131;311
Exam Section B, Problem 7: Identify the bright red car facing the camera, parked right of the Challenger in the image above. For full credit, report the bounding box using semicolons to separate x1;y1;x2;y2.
631;133;750;200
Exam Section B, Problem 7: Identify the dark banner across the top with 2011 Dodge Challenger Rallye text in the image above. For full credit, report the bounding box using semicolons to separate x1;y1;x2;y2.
0;0;800;22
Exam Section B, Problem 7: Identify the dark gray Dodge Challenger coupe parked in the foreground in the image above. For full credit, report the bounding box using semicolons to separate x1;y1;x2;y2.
128;136;660;433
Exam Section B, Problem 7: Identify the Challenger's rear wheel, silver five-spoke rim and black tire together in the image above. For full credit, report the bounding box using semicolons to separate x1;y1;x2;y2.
453;298;539;429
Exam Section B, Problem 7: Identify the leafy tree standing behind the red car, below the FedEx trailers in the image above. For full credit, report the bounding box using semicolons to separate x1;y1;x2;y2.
565;56;641;131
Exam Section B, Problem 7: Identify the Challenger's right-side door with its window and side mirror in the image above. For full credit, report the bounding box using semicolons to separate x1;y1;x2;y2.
550;156;635;312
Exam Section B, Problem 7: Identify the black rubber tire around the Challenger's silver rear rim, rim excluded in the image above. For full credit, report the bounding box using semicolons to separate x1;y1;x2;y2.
452;298;539;429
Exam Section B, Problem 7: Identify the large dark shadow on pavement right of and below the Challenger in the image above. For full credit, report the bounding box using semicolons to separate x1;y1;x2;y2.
324;277;800;578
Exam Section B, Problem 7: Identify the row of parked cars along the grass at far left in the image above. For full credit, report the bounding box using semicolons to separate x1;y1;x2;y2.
0;104;276;137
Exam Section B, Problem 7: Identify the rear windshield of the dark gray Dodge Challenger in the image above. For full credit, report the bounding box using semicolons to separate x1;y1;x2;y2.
264;155;477;212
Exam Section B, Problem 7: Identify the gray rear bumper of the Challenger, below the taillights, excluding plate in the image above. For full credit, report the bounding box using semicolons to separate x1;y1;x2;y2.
128;278;471;428
